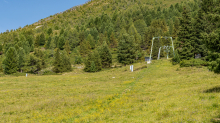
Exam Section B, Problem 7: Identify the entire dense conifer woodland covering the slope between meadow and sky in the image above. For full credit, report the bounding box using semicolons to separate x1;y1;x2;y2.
0;0;220;74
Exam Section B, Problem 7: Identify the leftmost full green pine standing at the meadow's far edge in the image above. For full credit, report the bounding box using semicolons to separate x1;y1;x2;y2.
3;47;18;74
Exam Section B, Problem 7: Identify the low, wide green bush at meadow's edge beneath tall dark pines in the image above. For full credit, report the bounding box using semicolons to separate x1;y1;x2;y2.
180;59;208;67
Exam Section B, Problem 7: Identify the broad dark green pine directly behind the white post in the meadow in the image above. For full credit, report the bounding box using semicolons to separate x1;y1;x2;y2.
117;33;136;65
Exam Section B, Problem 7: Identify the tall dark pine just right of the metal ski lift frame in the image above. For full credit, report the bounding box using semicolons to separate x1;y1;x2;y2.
177;8;194;60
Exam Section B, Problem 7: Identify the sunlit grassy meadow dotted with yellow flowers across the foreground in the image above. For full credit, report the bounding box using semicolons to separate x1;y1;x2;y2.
0;60;220;123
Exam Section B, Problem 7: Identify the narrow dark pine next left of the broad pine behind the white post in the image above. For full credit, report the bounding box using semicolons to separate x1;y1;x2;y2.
99;42;112;68
